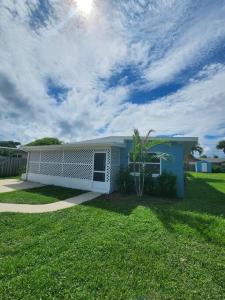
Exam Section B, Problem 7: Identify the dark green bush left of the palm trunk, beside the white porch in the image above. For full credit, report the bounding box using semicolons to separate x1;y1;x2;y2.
116;169;134;194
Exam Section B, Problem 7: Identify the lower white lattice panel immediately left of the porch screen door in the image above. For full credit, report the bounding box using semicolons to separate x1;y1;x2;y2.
63;164;92;180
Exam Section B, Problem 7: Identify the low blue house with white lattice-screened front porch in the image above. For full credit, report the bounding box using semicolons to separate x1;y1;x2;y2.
23;136;198;197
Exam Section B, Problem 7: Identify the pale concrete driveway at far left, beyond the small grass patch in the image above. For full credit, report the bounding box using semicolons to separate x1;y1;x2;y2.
0;179;43;193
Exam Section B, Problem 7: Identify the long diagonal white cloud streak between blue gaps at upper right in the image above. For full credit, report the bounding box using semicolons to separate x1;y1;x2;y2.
145;5;225;86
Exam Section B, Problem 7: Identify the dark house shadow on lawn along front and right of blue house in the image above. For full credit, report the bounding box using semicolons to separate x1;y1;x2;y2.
86;174;225;217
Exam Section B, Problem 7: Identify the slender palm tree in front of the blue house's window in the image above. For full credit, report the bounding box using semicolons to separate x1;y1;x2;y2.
131;129;169;197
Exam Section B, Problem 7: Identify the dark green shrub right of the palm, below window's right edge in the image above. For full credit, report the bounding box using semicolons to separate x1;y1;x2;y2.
158;172;177;198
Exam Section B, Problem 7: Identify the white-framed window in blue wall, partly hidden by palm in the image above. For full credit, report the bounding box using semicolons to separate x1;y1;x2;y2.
128;153;161;177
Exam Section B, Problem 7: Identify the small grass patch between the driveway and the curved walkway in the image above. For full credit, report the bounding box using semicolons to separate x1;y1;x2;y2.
0;185;84;204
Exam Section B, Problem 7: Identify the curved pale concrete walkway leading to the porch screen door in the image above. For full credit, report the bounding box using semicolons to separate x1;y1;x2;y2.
0;192;101;214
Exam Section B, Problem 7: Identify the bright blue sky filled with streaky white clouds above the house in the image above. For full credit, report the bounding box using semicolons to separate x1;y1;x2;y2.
0;0;225;155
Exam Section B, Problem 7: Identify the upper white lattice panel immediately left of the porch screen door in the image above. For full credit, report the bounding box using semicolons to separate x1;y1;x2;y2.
64;149;93;164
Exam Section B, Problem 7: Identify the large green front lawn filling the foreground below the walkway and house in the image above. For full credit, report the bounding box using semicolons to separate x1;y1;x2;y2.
0;173;225;300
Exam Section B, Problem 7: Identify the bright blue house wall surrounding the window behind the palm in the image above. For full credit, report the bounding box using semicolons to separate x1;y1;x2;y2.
120;140;184;198
